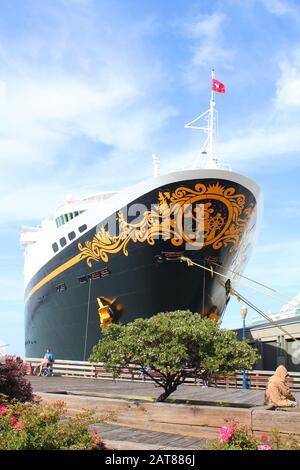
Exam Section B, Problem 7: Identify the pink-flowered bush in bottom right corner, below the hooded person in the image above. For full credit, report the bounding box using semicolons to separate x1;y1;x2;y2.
208;421;300;450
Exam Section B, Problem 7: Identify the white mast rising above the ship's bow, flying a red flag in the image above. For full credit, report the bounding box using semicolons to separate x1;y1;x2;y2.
184;69;229;169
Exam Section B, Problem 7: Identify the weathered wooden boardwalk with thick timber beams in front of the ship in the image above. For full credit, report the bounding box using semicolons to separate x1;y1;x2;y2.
28;376;300;450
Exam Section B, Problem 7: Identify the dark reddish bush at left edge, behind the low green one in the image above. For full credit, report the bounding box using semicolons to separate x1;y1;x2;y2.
0;356;34;403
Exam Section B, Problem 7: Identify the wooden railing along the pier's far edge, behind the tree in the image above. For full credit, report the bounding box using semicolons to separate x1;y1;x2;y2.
24;358;300;391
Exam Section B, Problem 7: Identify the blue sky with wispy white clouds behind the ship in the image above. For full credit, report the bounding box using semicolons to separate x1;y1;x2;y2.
0;0;300;355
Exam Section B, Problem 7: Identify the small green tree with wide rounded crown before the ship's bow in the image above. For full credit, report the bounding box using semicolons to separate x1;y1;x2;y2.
90;311;258;401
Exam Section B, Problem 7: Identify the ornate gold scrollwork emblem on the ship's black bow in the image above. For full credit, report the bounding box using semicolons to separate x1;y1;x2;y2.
78;182;253;267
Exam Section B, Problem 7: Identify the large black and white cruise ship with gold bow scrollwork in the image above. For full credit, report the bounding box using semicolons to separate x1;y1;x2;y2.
21;74;262;360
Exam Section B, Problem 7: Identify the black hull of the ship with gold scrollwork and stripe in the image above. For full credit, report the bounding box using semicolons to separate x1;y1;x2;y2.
25;173;257;360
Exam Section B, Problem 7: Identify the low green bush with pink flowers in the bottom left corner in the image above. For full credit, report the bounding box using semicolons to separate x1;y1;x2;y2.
0;402;104;450
